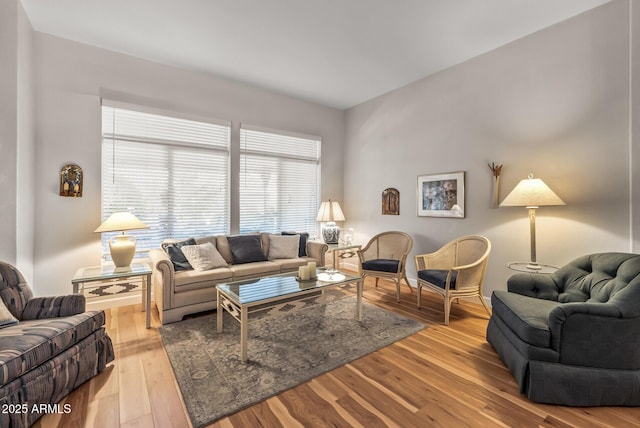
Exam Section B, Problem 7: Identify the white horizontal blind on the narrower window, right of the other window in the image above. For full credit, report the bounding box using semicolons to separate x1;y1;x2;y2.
240;126;320;236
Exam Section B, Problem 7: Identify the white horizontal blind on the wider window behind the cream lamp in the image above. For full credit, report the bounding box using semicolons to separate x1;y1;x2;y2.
102;105;230;255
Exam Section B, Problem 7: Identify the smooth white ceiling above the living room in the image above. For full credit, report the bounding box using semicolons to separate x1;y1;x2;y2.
21;0;609;109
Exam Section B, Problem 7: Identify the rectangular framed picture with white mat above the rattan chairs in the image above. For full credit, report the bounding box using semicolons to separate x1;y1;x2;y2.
417;171;464;218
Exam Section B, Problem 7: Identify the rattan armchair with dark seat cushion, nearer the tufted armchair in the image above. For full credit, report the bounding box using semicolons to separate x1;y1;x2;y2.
415;235;491;325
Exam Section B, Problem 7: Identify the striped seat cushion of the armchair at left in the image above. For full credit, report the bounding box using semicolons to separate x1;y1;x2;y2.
0;311;105;385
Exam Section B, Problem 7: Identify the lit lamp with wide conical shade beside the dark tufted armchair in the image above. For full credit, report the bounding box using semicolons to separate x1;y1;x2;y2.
500;174;566;270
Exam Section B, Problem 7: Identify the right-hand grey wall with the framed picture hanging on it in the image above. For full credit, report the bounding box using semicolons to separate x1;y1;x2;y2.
344;1;631;296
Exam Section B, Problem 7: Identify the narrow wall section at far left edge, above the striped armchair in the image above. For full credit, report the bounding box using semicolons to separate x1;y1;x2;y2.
0;0;34;280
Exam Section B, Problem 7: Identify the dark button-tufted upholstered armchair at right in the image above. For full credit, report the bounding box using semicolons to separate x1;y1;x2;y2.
487;253;640;406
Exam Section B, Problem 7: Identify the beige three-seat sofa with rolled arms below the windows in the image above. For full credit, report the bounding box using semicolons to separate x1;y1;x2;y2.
149;233;328;324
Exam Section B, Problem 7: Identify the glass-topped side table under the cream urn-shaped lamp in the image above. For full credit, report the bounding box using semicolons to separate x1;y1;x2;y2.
71;263;151;328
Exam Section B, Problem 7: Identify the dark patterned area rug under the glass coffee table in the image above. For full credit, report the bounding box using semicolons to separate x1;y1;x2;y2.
160;296;425;428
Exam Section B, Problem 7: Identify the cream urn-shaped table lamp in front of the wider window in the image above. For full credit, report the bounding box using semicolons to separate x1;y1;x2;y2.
94;211;149;270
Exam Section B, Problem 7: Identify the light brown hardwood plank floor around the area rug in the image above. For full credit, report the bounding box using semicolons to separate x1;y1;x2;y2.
35;279;640;428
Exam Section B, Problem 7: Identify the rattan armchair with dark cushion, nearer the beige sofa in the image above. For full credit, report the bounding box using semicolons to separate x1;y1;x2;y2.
358;231;413;302
